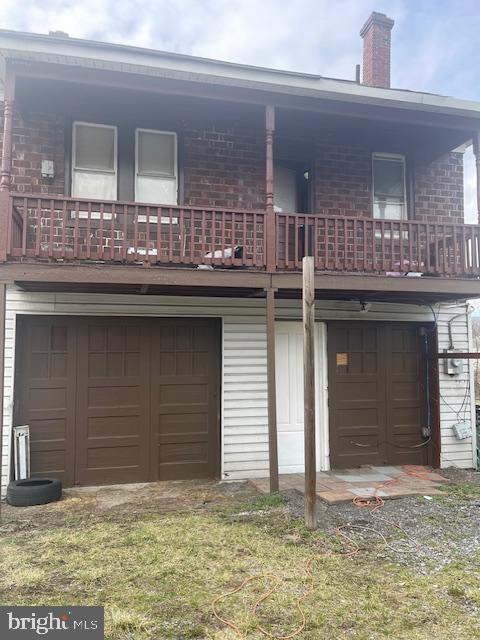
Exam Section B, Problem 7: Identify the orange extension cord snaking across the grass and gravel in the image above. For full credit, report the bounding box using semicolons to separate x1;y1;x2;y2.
211;465;428;640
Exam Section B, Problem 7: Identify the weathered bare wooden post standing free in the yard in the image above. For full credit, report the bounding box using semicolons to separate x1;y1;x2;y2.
302;256;317;530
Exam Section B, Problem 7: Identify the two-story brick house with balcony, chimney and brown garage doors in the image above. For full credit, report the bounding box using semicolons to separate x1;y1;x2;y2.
0;13;480;486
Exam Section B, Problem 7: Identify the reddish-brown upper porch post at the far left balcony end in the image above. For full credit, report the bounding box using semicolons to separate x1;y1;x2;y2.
0;64;15;262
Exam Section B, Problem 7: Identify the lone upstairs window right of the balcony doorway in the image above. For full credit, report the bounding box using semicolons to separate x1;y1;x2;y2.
372;153;408;220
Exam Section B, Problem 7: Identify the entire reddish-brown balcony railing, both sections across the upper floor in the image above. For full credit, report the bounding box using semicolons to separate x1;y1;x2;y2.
8;195;480;278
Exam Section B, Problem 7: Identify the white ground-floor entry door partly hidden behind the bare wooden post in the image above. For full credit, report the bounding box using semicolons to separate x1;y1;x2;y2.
275;321;328;473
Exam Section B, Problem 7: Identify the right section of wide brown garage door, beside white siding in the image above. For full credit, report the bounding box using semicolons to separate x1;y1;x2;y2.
151;319;219;480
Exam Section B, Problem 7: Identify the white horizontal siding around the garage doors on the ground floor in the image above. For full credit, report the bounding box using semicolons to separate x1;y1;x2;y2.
2;287;475;486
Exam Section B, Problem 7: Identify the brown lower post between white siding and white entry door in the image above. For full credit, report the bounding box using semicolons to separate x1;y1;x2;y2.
266;288;279;493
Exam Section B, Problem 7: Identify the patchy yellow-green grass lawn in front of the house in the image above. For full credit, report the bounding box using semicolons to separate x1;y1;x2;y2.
0;488;480;640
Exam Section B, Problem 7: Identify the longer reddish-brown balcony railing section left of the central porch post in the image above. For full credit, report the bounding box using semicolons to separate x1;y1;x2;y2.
10;195;265;267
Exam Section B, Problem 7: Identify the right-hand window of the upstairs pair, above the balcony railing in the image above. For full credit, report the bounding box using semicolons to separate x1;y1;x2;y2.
135;129;178;205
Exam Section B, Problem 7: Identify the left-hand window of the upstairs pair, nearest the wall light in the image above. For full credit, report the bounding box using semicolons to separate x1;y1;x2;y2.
72;122;117;200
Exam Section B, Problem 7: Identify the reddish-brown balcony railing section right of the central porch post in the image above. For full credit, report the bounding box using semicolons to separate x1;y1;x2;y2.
277;214;480;276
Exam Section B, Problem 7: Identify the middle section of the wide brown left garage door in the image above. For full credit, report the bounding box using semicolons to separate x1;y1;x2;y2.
76;318;150;484
